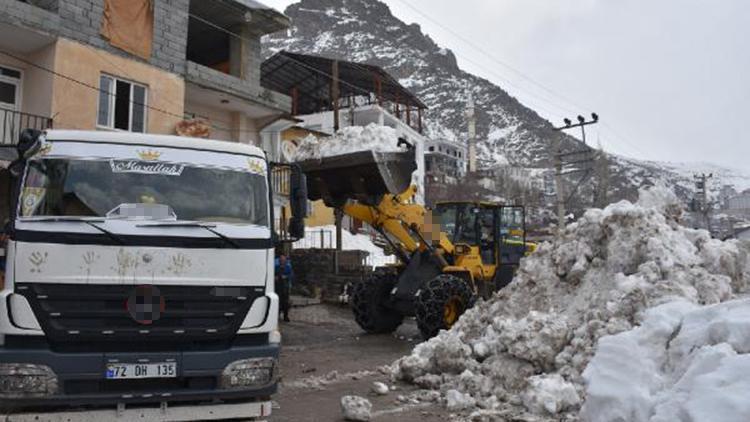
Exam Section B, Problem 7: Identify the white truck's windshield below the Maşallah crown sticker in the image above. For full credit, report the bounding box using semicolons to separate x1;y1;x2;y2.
19;158;269;227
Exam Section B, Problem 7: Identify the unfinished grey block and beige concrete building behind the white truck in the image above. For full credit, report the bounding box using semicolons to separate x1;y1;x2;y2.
0;0;291;144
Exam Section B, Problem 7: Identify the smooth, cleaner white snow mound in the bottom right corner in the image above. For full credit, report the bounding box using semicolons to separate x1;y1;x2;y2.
581;299;750;422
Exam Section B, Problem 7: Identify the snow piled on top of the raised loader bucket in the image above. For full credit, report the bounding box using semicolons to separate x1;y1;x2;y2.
290;123;406;161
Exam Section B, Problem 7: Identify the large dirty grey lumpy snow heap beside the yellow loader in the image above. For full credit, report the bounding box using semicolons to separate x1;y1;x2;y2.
394;188;750;420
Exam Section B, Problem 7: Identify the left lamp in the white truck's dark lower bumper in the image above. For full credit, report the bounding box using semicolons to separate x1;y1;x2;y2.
0;363;58;399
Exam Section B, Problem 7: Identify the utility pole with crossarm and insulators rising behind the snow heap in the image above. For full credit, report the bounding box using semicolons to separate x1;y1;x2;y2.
552;113;599;235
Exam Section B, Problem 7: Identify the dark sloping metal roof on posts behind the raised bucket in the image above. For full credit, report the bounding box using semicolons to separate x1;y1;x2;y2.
261;51;427;115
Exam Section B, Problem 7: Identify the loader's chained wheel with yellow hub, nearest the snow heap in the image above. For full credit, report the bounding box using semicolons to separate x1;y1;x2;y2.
415;274;475;340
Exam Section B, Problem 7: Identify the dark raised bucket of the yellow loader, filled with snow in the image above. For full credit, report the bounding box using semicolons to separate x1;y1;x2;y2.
298;149;417;208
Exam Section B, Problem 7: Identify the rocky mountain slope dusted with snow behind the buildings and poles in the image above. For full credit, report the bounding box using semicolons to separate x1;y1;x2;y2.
263;0;748;206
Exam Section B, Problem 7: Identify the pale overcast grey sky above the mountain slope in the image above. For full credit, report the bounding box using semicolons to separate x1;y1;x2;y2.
262;0;750;173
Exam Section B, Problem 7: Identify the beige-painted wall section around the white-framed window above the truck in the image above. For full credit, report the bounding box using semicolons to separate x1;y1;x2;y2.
52;38;185;134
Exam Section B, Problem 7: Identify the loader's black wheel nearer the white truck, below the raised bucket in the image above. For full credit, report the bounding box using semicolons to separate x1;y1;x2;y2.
352;270;404;334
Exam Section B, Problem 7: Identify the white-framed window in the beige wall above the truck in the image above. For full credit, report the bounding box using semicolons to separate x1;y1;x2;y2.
96;75;148;133
